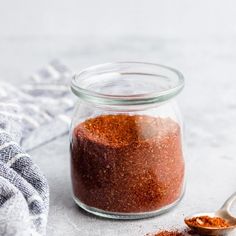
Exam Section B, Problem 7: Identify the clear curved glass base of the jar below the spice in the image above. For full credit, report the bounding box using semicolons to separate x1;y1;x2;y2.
73;192;184;220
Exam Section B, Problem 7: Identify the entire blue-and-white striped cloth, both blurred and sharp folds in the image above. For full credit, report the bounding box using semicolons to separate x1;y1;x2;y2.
0;61;74;236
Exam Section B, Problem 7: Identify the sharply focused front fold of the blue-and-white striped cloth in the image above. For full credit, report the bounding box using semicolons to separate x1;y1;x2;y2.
0;129;49;236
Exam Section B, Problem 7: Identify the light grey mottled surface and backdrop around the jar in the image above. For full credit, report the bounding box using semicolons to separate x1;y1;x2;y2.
0;0;236;236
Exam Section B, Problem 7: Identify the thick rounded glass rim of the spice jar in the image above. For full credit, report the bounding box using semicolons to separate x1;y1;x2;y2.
71;61;184;105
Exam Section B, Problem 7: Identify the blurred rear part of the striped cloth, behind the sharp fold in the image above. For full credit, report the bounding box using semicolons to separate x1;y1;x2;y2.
0;60;74;151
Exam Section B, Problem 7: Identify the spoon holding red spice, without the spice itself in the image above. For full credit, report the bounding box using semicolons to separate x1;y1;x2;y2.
184;193;236;235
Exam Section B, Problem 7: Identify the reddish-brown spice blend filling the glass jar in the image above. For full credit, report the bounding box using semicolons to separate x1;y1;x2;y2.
71;115;184;213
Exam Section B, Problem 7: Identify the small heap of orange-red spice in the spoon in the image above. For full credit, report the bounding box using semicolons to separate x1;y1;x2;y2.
185;216;230;228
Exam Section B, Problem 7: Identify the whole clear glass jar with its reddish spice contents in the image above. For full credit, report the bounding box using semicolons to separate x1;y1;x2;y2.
70;62;184;219
